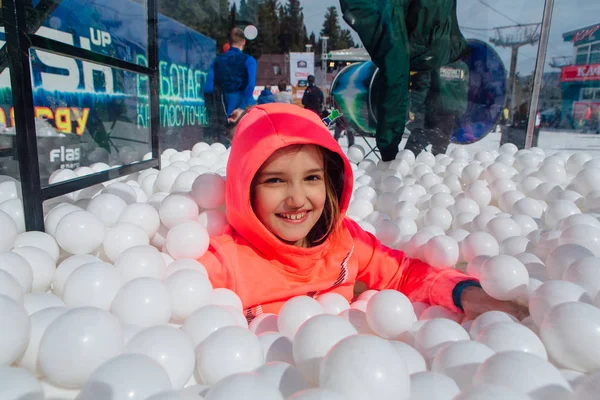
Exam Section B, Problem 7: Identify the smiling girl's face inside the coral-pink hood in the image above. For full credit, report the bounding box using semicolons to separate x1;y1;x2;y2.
252;145;327;246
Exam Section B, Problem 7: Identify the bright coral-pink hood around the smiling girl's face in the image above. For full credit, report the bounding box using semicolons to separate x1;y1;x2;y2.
226;103;353;255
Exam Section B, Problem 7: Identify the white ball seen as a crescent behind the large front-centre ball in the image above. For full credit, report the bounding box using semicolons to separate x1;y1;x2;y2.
293;314;357;386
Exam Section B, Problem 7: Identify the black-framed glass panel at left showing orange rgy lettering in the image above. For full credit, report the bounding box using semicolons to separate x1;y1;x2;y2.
30;50;152;186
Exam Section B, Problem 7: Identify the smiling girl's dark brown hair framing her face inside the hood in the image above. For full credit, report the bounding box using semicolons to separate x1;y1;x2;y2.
250;144;344;247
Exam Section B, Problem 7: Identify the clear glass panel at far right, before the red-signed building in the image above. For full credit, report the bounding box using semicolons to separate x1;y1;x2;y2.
538;0;600;155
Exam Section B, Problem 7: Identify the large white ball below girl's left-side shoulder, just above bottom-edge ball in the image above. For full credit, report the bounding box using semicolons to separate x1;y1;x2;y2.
196;326;265;385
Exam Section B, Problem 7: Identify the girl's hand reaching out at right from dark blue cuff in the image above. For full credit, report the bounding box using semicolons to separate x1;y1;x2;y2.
460;286;529;321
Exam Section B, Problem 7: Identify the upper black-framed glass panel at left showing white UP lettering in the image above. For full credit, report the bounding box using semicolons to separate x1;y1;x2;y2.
28;0;148;63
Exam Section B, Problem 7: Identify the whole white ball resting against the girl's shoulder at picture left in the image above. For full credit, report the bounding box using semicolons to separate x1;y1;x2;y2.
165;221;209;260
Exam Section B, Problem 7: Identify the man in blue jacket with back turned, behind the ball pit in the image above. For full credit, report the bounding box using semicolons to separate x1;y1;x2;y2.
204;28;257;116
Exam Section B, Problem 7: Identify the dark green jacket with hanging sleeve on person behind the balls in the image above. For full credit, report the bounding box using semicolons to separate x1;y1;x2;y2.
340;0;469;161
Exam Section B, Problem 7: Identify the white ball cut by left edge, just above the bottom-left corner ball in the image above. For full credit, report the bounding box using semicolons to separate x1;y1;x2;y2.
0;295;31;368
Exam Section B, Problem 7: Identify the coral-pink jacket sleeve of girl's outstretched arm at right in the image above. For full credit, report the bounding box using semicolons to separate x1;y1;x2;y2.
346;218;477;312
